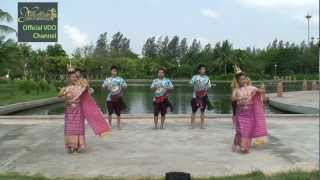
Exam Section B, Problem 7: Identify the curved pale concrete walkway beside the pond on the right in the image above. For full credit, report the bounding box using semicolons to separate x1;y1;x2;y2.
267;91;319;114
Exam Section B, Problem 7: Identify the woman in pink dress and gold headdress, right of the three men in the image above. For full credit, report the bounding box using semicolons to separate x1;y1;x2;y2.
232;66;267;153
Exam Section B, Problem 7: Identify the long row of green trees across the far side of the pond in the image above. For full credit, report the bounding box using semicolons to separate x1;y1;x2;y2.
0;29;319;81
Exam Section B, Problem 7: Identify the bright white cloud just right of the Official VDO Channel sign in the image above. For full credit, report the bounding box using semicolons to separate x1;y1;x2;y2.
63;25;89;47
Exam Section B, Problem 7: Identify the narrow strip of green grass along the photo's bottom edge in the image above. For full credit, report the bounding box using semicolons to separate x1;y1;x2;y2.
0;170;320;180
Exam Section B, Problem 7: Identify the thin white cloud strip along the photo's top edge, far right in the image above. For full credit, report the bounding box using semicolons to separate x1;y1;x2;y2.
238;0;317;8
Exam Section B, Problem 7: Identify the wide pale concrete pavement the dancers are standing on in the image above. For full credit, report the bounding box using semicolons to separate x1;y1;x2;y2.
0;115;319;179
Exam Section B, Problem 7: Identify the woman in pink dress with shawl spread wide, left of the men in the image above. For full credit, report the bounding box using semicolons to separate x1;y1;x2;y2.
58;69;111;153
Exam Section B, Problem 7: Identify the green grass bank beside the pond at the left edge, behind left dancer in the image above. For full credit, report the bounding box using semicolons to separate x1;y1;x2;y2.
0;83;57;106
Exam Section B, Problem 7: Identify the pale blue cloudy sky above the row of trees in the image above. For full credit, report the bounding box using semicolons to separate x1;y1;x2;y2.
0;0;319;55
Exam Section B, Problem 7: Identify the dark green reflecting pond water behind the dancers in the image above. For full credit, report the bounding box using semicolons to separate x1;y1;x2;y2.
14;82;302;115
